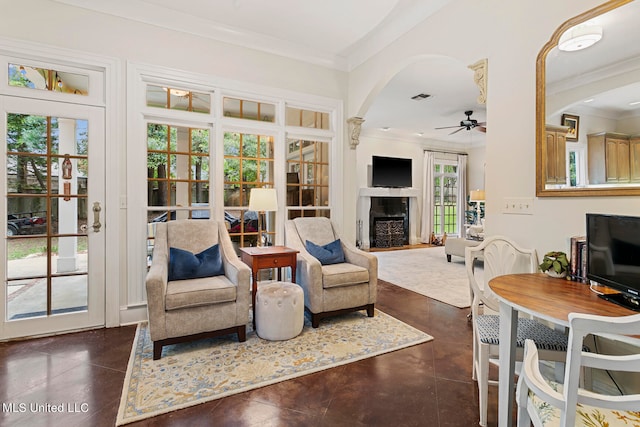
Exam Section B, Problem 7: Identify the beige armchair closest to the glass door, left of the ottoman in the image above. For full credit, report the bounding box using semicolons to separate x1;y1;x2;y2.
146;219;251;360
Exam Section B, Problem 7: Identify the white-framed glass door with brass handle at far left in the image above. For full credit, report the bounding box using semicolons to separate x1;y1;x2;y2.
0;96;105;339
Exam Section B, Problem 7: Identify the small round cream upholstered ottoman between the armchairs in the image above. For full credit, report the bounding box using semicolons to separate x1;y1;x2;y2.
256;282;304;341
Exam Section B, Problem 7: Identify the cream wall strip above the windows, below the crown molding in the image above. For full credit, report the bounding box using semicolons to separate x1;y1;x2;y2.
0;0;347;99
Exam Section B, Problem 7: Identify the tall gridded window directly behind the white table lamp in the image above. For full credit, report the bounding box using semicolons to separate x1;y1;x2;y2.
224;132;276;247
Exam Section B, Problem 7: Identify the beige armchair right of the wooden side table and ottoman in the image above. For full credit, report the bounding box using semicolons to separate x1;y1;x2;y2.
285;217;378;328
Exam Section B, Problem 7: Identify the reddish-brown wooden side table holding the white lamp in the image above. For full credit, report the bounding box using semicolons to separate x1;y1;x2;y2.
240;246;299;330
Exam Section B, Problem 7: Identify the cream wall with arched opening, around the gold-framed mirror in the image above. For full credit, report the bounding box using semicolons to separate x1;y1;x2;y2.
347;0;640;254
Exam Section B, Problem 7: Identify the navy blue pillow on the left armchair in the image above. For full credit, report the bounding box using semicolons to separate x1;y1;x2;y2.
169;245;224;280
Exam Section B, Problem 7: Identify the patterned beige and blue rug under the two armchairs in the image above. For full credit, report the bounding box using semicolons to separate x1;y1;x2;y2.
116;310;433;425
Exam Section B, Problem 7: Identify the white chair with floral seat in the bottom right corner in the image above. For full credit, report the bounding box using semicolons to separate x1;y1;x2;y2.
516;313;640;427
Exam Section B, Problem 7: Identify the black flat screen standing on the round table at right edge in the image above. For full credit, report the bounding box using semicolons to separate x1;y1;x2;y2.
587;213;640;311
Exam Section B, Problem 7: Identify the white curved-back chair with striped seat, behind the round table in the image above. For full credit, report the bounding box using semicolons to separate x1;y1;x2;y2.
465;236;567;426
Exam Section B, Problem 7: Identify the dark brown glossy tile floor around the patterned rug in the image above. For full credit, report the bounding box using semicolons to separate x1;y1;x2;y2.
0;282;497;427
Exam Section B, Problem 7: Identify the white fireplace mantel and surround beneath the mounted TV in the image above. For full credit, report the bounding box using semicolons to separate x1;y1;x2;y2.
358;187;420;250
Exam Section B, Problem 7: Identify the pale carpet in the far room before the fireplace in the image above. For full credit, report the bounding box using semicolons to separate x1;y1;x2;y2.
372;246;478;308
